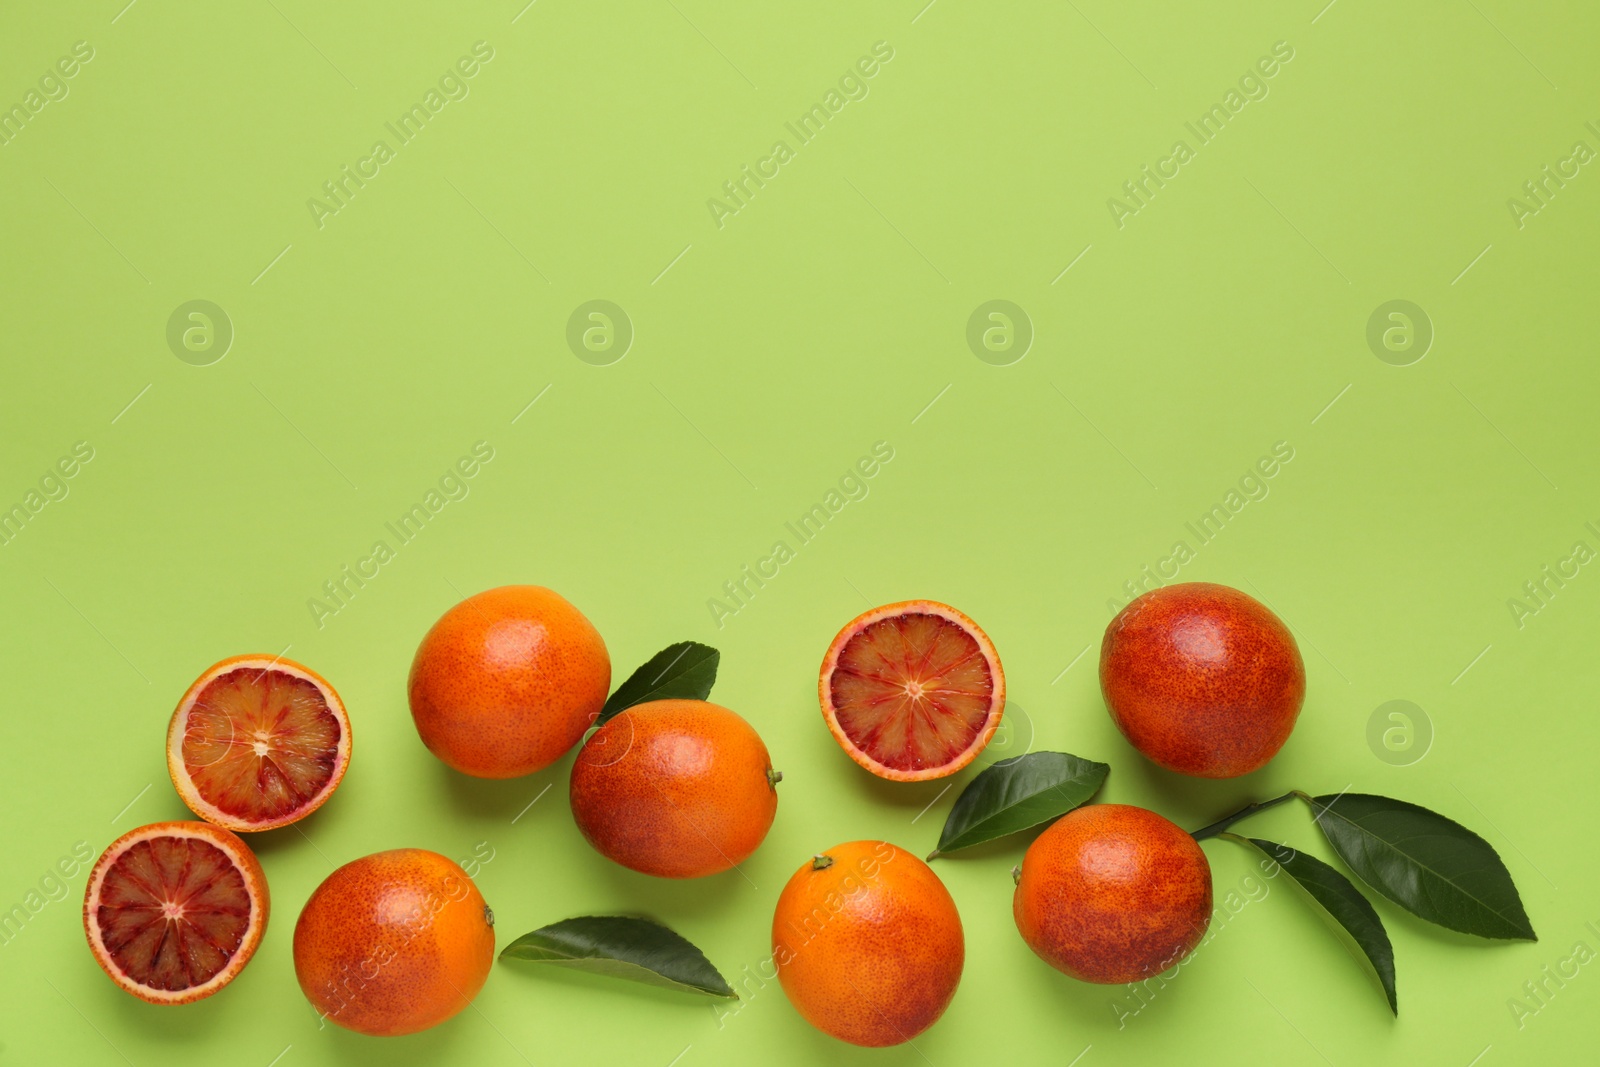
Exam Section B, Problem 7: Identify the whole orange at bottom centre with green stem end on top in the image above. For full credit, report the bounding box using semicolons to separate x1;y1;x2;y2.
773;841;966;1048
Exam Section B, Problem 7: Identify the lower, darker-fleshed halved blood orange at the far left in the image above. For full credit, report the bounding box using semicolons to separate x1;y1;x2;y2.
83;822;272;1005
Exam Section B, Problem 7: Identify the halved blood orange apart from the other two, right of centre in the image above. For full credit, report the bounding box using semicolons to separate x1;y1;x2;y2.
818;600;1005;782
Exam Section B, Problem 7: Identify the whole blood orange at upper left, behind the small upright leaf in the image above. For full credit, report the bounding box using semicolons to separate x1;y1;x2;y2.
408;585;611;777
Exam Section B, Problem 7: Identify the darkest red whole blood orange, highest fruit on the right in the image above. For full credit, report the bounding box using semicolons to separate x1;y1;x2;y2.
1099;582;1306;777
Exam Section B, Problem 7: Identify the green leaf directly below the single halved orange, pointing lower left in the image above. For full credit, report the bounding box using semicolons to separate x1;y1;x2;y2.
928;752;1110;859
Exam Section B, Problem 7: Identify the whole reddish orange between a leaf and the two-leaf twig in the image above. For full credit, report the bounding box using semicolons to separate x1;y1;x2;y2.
1011;805;1211;984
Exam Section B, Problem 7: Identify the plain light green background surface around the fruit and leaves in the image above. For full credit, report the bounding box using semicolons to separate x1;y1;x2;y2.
0;0;1600;1067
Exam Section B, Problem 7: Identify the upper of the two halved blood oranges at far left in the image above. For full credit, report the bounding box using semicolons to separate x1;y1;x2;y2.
166;656;350;832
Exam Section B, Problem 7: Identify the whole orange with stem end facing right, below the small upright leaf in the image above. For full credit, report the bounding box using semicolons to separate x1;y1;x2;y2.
571;701;781;878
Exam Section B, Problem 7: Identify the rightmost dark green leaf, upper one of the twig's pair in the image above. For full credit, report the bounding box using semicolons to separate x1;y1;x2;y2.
1302;793;1539;941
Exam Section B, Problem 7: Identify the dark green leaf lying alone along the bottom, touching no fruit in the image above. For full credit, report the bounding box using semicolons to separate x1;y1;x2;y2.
501;915;739;1000
